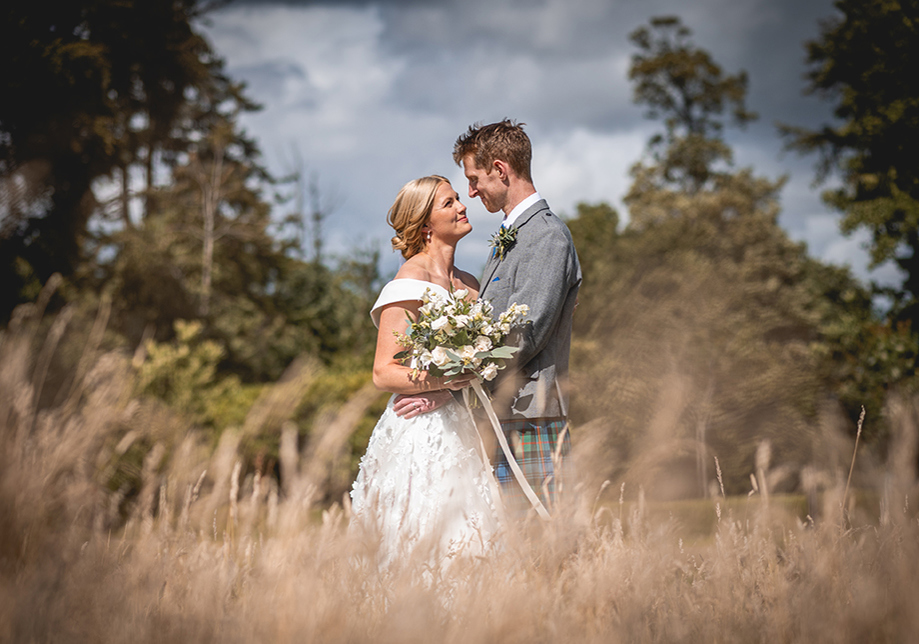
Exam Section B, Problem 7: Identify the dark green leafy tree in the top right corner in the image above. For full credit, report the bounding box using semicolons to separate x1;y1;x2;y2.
781;0;919;320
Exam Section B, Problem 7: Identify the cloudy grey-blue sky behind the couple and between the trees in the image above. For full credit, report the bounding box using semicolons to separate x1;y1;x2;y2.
199;0;895;282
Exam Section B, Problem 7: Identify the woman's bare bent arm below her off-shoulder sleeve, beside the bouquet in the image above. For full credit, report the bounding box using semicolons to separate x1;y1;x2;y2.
373;301;475;394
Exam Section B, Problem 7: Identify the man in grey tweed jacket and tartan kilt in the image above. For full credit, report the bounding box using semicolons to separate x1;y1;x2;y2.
453;119;581;515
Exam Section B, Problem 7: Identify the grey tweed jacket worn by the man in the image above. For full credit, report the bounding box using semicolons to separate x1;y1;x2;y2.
479;199;581;420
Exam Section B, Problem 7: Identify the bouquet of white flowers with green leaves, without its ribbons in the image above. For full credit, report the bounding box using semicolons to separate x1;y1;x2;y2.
394;289;529;380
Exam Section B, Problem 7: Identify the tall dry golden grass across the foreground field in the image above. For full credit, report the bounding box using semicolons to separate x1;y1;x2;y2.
0;298;919;644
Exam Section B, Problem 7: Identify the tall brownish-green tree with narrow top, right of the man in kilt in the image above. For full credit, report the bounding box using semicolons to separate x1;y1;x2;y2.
570;18;870;495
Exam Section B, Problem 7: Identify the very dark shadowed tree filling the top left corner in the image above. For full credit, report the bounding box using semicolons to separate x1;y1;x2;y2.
0;0;230;319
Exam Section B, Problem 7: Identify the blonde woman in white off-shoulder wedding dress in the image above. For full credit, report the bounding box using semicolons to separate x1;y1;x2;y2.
351;175;500;568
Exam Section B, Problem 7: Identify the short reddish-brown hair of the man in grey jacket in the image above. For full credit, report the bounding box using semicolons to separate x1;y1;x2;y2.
453;119;533;182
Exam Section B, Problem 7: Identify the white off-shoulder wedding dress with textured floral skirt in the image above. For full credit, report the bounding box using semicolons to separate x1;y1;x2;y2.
351;279;501;568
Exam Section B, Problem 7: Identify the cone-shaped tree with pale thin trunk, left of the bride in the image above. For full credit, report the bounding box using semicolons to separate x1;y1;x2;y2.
96;109;292;380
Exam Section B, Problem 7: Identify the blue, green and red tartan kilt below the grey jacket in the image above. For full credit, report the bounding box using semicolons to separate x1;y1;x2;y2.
494;417;571;518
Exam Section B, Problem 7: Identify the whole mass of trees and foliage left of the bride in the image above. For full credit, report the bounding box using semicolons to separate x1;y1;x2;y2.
0;0;378;381
